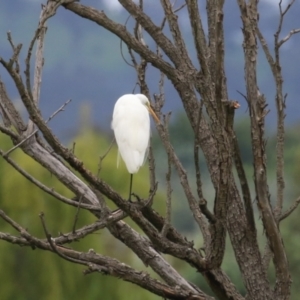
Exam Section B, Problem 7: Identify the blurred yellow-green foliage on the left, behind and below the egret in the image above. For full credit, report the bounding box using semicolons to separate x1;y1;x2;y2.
0;128;162;300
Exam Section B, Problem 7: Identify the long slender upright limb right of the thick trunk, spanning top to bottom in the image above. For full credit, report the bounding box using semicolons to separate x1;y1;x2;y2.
238;0;290;298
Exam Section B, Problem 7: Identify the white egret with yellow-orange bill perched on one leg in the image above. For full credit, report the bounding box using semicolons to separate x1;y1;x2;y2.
111;94;160;200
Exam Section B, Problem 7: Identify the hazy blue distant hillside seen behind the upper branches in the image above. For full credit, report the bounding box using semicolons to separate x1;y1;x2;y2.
0;0;300;137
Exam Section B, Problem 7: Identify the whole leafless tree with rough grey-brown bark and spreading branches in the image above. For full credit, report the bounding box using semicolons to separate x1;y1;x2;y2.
0;0;300;300
